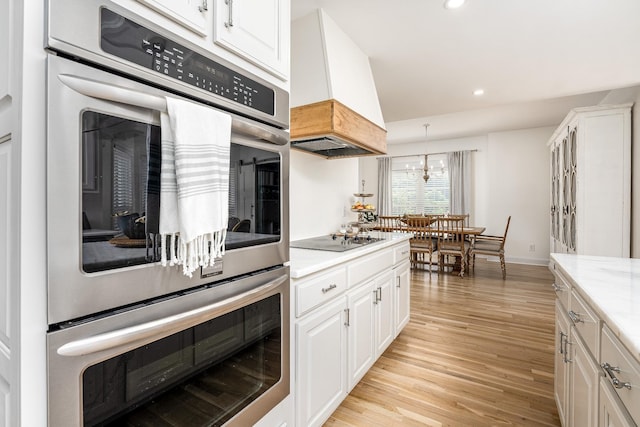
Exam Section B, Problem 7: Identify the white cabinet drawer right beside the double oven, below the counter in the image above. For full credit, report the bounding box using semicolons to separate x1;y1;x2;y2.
295;267;347;317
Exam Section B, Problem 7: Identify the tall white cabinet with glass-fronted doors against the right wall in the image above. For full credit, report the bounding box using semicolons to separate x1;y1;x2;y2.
549;104;632;257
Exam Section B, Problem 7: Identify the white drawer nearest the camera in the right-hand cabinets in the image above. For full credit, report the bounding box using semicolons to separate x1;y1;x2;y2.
600;326;640;424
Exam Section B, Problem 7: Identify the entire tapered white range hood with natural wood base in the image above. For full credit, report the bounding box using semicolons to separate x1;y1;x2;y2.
290;9;387;159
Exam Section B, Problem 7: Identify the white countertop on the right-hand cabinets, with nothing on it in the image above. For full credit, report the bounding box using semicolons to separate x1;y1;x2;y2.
551;254;640;360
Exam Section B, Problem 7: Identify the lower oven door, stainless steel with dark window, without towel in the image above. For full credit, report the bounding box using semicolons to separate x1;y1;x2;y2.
47;267;290;427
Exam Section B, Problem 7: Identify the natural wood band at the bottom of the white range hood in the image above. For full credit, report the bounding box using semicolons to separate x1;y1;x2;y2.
290;99;387;158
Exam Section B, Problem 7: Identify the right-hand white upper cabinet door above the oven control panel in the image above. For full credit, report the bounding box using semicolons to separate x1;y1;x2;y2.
214;0;290;80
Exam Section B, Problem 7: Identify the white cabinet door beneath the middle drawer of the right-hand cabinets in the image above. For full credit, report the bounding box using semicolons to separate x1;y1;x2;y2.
568;334;600;427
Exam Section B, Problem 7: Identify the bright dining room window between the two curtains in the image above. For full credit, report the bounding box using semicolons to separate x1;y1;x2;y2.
391;154;449;215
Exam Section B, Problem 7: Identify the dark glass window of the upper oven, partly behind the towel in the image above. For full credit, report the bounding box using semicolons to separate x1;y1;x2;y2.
81;111;282;273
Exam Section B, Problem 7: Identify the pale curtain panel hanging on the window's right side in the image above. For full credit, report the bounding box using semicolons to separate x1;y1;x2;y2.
447;151;471;214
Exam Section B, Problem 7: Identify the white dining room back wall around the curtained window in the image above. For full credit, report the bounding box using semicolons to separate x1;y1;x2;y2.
360;127;555;264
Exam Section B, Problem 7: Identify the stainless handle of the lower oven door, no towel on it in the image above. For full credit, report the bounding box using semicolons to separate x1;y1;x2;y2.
58;274;289;356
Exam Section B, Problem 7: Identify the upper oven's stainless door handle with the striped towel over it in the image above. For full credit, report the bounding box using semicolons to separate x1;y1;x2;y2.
58;74;289;145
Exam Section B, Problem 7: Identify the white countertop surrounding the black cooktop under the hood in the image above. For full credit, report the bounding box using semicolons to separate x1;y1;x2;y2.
289;232;411;279
